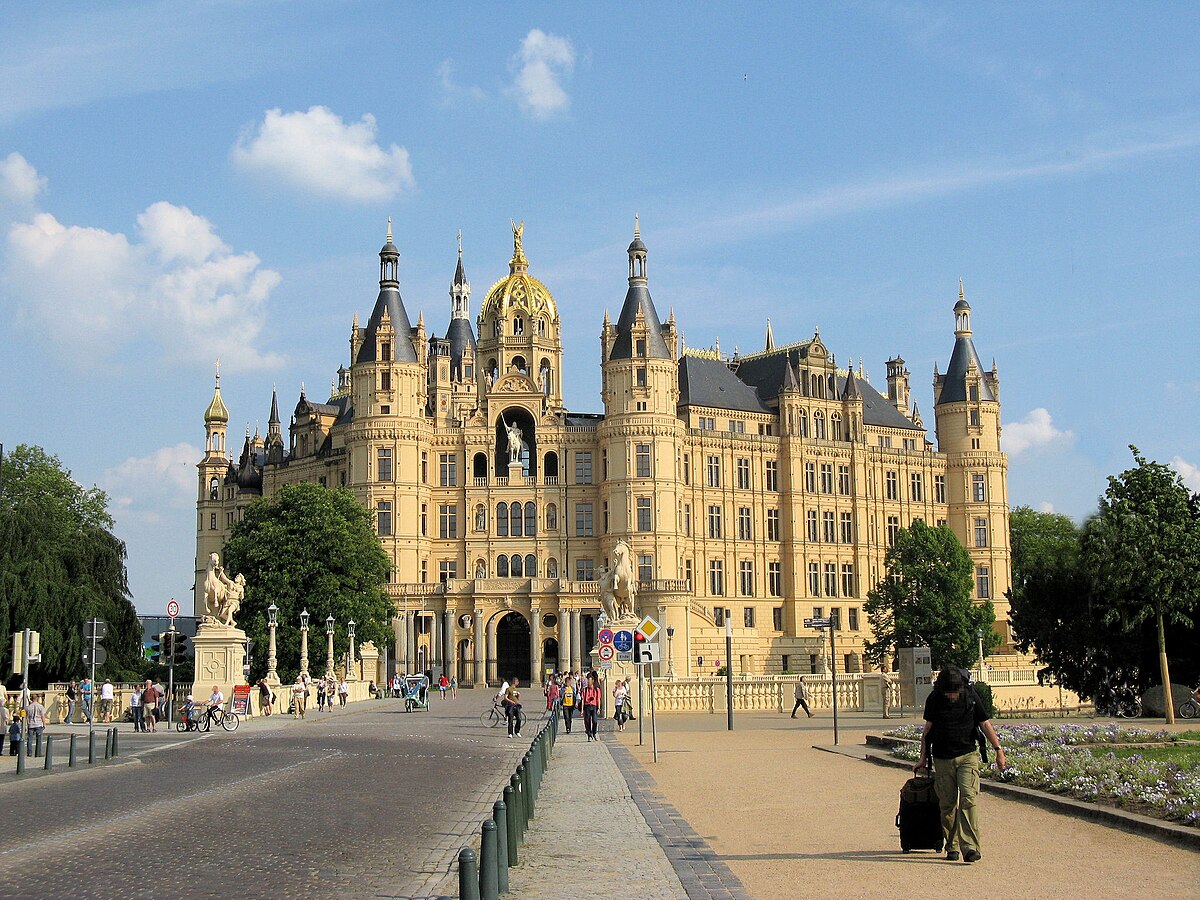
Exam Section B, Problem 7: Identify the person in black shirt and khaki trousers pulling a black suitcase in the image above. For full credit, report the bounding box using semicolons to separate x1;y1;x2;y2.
912;667;1004;863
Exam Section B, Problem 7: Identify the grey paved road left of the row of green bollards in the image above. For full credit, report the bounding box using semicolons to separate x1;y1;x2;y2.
0;691;534;898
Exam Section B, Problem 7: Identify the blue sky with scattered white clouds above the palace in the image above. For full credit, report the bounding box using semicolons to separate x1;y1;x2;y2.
0;1;1200;614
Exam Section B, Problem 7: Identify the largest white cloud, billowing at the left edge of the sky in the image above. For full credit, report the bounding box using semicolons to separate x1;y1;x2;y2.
0;173;281;370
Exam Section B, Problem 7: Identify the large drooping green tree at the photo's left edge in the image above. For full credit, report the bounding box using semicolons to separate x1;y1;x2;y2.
0;445;143;686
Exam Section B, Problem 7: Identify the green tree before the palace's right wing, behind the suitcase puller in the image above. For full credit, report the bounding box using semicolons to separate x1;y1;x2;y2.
863;520;1000;668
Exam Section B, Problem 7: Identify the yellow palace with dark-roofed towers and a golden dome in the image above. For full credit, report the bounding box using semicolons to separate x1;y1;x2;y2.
196;223;1013;684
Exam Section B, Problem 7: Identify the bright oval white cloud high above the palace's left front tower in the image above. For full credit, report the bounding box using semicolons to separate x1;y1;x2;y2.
230;106;414;203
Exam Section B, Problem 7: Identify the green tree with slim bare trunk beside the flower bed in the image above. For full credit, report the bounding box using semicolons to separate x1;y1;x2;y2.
1081;444;1200;725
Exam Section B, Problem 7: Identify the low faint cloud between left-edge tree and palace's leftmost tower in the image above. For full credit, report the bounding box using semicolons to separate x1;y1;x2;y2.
100;443;204;524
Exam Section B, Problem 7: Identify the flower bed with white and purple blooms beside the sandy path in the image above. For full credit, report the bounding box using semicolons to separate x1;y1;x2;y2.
884;722;1200;827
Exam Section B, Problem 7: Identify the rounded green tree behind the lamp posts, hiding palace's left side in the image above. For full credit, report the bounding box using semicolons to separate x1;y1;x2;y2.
222;484;392;679
